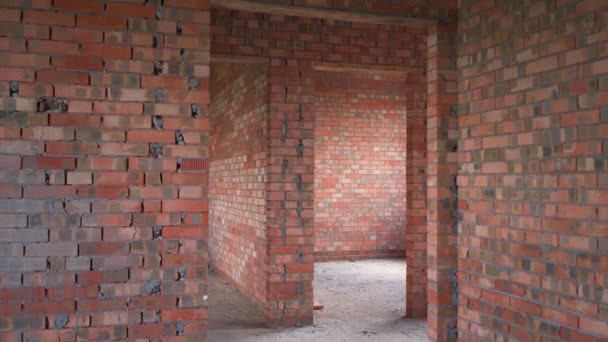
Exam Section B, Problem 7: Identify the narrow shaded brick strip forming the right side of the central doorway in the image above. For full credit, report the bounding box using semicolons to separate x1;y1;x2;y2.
405;81;427;318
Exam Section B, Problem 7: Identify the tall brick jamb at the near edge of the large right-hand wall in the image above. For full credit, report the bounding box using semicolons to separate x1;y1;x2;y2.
427;25;458;341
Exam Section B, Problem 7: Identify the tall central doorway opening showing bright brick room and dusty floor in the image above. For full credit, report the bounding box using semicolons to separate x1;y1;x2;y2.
312;71;426;341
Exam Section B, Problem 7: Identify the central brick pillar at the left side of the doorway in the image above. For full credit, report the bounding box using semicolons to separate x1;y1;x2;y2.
266;60;314;327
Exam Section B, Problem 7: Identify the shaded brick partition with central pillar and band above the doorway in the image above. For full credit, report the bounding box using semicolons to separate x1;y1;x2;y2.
211;10;427;326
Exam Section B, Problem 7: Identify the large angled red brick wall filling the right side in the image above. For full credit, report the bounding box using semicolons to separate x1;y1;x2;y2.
458;0;608;341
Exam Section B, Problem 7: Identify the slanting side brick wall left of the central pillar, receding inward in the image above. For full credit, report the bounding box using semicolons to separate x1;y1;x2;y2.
209;63;269;304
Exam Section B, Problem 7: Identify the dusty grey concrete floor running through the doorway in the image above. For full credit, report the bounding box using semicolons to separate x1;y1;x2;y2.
209;259;427;342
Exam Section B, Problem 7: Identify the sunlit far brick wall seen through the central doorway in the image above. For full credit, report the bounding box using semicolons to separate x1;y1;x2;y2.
313;72;407;260
